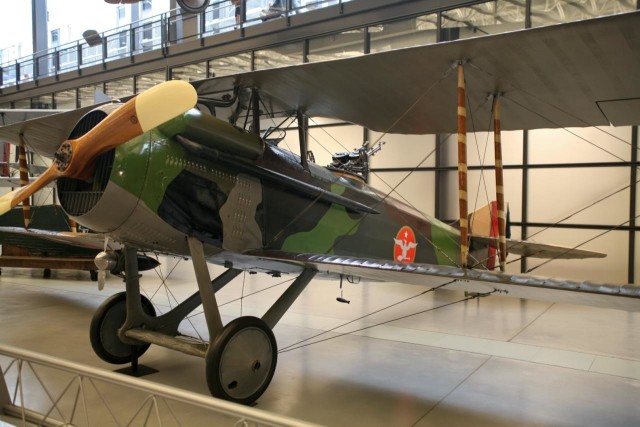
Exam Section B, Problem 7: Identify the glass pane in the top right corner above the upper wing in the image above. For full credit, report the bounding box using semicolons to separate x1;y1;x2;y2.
531;0;636;27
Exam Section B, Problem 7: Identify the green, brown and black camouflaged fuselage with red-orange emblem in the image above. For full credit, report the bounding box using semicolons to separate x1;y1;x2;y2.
61;110;468;270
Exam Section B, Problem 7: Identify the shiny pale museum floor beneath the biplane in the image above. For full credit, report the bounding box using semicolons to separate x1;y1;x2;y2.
0;261;640;426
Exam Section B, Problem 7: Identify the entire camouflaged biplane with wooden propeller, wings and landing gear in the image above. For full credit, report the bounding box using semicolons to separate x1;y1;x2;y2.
0;12;640;403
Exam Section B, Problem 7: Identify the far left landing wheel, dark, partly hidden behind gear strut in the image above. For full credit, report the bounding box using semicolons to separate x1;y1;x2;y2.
89;292;156;365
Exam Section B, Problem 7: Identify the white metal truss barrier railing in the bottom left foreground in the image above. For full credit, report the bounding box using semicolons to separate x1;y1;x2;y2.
0;345;317;427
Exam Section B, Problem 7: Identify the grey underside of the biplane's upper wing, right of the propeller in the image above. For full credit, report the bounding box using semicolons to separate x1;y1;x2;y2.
193;12;640;134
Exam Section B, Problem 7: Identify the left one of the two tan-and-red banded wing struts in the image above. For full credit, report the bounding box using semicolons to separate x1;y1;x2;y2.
458;61;469;267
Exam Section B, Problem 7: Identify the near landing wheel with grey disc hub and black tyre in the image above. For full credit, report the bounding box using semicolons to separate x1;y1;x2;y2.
206;316;278;404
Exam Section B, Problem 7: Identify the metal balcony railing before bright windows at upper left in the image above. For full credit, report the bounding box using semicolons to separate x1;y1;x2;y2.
0;0;351;88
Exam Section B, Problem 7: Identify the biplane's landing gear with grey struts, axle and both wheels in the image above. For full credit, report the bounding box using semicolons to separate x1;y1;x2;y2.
91;241;316;404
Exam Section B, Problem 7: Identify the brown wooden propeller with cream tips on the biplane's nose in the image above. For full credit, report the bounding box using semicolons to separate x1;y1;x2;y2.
0;80;198;215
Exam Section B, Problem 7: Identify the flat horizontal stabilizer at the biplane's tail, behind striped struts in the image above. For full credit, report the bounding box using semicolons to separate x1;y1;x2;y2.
471;236;607;259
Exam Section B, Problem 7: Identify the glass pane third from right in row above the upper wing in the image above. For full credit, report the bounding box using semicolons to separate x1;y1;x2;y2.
369;14;438;52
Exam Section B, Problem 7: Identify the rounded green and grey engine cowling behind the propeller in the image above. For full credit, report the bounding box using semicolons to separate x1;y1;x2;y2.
57;104;187;253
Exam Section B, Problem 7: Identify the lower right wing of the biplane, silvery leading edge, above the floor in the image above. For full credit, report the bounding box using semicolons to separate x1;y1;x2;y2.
249;251;640;311
